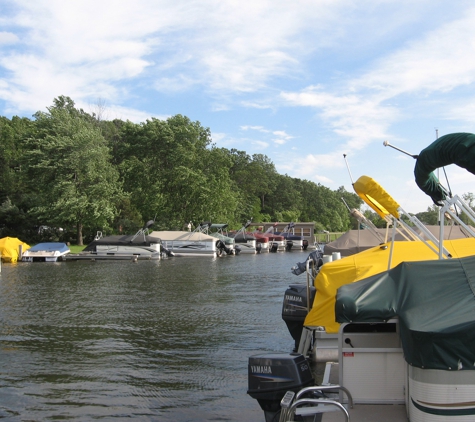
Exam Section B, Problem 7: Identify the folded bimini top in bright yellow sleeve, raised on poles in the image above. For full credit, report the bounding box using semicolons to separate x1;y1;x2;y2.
353;176;400;219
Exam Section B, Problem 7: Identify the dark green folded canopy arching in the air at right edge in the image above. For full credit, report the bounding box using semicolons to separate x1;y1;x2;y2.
414;133;475;204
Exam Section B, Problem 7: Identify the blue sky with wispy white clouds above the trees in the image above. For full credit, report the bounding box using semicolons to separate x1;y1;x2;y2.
0;0;475;213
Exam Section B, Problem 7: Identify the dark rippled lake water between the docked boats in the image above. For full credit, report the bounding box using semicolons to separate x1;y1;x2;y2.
0;251;308;422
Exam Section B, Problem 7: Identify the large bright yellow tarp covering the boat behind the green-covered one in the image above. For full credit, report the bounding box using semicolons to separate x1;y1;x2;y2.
304;238;475;333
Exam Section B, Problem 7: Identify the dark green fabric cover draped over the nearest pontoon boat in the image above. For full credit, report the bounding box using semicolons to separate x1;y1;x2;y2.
335;256;475;370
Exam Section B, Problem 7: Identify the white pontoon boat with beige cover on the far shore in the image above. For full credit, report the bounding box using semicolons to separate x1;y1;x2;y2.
150;230;217;257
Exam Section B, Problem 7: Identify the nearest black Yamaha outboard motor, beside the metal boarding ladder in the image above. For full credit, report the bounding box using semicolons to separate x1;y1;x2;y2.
247;353;314;422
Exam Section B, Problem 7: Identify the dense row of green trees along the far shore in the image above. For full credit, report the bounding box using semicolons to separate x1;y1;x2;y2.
0;96;446;245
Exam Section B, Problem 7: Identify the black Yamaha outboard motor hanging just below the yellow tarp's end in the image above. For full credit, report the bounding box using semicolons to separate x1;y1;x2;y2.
282;284;316;352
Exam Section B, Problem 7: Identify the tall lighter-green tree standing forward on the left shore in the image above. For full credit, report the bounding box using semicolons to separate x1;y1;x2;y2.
25;97;122;245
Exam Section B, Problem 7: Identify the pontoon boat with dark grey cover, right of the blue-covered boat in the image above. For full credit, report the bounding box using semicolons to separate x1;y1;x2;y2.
66;220;173;261
